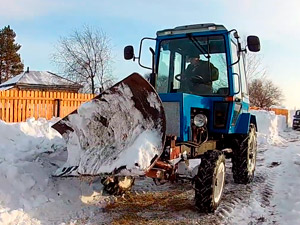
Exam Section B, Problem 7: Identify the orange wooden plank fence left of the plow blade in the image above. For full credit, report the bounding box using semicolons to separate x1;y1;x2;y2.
0;90;94;122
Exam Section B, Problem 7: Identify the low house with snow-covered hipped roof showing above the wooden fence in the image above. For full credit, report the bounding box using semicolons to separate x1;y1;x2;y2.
0;68;82;93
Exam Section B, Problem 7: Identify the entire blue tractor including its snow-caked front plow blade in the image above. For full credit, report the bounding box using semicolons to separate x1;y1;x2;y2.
53;24;260;212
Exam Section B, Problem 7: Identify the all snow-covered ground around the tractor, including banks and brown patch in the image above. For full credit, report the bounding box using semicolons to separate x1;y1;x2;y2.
0;111;300;224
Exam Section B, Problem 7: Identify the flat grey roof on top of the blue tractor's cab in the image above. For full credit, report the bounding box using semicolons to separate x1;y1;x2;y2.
156;23;227;36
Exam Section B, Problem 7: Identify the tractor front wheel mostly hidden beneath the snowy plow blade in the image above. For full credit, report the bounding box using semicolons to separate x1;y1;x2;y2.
101;176;134;195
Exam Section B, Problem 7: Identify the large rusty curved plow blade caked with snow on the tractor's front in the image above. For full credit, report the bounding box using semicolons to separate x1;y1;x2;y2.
52;73;166;176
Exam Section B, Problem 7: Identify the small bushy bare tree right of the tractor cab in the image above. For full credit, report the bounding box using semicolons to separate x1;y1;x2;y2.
249;79;283;108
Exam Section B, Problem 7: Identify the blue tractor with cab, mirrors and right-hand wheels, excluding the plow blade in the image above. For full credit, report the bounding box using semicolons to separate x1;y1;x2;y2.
124;24;260;212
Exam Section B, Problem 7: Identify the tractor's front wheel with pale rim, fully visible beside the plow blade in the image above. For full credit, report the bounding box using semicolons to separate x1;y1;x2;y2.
194;150;225;213
